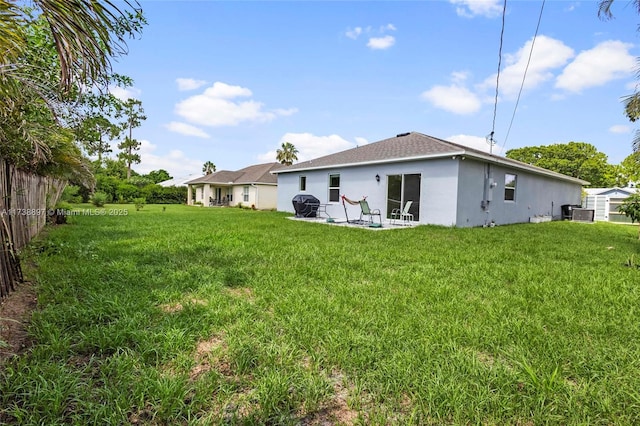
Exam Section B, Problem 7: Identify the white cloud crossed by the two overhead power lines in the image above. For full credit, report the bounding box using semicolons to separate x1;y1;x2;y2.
479;36;574;98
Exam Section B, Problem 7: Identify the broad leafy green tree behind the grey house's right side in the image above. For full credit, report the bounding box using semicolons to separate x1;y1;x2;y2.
506;142;616;187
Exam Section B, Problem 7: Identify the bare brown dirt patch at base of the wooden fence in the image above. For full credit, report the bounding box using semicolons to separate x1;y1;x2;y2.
0;282;37;366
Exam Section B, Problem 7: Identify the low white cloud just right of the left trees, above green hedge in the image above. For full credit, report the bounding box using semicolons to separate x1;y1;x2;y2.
135;139;204;177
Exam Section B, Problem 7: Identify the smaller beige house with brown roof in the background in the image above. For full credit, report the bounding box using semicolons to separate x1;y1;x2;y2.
187;163;282;210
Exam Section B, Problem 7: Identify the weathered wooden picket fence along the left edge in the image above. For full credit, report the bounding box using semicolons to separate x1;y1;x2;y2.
0;159;66;298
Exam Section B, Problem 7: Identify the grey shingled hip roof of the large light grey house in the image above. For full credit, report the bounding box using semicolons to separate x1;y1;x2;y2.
274;132;589;185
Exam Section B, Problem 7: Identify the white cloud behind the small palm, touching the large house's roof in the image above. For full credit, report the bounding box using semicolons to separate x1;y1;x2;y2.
258;133;358;162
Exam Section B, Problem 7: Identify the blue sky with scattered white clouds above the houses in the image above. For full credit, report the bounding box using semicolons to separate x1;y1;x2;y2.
109;0;640;177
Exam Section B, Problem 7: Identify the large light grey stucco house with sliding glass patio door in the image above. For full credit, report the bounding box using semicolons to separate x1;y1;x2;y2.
274;132;588;227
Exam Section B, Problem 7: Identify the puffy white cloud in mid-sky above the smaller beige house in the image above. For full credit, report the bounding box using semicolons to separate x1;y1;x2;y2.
175;82;297;127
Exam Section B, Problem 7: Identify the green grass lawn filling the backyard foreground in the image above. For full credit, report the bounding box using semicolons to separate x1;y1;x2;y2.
0;205;640;425
